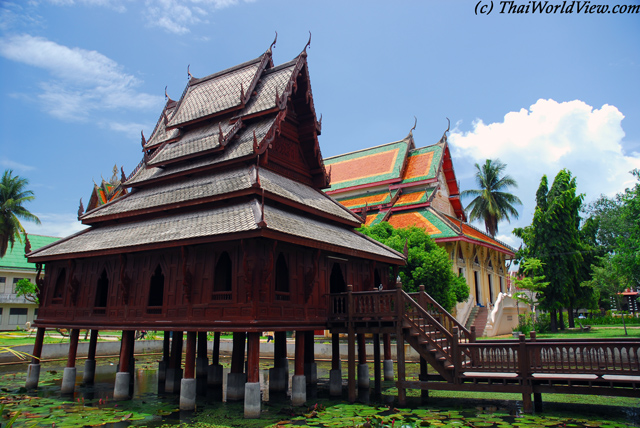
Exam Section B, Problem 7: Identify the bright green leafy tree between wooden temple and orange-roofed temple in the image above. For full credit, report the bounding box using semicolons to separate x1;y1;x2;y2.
360;222;469;311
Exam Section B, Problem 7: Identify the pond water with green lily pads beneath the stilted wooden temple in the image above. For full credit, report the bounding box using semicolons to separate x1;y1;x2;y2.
0;358;640;428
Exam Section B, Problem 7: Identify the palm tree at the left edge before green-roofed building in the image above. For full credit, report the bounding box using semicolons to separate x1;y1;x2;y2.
0;169;40;257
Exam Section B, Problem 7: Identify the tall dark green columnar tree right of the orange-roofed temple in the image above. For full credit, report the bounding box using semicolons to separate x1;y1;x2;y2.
514;169;593;332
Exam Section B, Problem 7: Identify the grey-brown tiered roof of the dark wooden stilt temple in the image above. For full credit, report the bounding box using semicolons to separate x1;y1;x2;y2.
30;41;403;264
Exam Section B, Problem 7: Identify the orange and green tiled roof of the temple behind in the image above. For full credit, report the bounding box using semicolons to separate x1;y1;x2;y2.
324;133;514;255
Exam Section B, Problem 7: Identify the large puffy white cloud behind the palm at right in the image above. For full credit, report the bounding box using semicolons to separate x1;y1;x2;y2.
449;99;640;236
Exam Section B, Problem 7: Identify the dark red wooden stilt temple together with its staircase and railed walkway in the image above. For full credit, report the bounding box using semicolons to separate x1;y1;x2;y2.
26;36;640;418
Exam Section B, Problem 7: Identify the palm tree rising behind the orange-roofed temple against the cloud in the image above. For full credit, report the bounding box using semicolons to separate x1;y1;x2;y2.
462;159;522;237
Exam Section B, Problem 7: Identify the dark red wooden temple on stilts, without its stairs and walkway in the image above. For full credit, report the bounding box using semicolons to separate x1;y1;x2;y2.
27;41;405;417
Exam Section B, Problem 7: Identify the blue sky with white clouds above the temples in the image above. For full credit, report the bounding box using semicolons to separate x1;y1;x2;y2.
0;0;640;245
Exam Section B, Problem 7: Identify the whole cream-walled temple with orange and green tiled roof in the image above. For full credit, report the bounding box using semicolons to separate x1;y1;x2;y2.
324;130;517;335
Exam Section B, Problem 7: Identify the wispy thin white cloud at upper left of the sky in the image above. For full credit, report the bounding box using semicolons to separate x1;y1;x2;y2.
0;34;162;120
